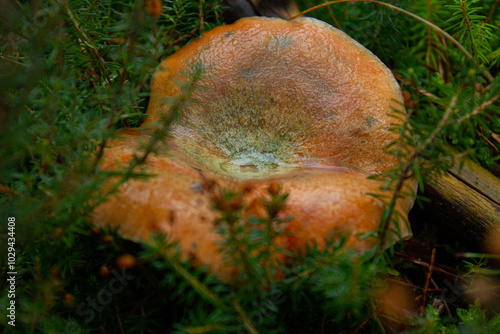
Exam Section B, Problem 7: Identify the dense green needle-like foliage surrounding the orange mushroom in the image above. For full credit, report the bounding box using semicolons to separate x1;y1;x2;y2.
0;0;500;333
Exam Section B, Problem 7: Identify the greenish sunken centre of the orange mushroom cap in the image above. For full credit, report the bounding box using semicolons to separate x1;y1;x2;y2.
172;88;311;179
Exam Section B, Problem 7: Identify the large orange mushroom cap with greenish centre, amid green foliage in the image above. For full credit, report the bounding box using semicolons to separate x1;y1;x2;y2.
94;18;416;280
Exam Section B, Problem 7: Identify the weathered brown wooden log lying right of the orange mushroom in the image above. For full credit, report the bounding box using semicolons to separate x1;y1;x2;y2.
410;161;500;250
